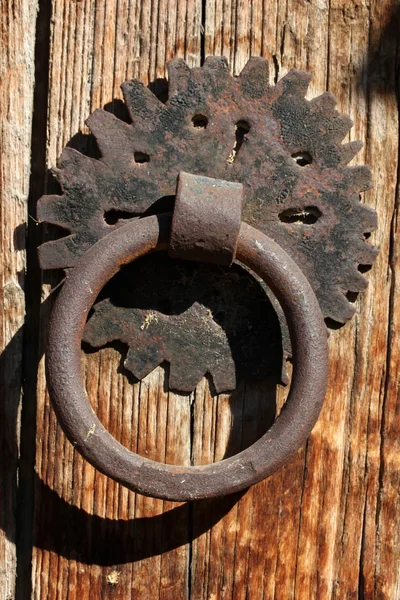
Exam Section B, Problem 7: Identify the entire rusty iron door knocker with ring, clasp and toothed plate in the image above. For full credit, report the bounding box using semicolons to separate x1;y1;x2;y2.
37;57;377;501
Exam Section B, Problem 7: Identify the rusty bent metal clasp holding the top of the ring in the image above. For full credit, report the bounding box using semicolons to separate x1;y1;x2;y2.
168;173;243;267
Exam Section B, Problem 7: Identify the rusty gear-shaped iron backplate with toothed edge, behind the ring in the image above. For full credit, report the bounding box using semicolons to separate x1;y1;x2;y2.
37;57;377;391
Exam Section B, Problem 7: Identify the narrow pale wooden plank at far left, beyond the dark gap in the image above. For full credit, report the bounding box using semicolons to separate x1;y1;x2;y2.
0;0;37;600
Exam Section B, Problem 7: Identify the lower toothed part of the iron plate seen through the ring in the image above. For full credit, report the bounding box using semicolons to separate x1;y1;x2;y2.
83;251;290;393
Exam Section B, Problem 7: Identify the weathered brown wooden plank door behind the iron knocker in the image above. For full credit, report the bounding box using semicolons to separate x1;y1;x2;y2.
0;0;400;600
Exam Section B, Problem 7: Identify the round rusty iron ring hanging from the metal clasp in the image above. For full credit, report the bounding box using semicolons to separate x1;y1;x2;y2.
46;214;328;501
